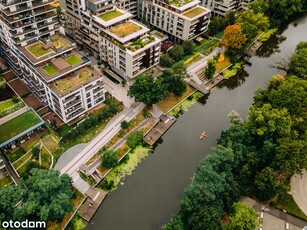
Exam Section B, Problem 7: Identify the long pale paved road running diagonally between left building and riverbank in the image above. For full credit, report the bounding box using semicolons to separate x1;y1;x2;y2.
61;103;145;178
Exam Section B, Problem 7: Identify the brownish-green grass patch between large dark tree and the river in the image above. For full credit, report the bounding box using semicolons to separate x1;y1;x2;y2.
158;86;195;113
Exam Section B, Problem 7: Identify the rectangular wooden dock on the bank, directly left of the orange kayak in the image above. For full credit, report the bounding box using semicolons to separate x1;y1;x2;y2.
143;114;176;145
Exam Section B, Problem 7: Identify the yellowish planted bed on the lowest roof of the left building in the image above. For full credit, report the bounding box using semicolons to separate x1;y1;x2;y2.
55;69;94;92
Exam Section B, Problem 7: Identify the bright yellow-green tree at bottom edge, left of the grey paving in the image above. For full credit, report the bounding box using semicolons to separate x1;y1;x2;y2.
223;202;258;230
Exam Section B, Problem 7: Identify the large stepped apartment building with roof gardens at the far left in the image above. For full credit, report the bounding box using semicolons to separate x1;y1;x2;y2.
0;0;105;122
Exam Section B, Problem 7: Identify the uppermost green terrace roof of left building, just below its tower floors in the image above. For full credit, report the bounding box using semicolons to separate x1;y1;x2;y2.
19;35;76;64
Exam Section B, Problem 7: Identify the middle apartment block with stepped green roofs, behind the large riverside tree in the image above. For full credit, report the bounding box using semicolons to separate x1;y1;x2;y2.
62;0;161;80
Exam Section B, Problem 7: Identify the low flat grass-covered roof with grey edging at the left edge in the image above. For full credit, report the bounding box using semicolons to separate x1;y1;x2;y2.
0;109;45;148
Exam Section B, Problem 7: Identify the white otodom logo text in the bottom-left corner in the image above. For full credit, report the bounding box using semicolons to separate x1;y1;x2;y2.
1;220;47;229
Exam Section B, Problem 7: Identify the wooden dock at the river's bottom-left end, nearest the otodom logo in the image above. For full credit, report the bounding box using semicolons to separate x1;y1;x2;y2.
78;187;107;222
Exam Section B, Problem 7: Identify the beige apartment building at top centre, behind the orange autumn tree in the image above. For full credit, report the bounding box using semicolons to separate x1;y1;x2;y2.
139;0;211;42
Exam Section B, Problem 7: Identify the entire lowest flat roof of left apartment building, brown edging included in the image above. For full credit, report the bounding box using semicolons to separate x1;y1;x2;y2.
50;66;101;96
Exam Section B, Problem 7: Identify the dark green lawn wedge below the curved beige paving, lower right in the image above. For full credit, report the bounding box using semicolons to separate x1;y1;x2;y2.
276;194;307;221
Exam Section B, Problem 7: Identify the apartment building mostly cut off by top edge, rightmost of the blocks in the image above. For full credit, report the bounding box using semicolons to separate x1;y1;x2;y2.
202;0;251;16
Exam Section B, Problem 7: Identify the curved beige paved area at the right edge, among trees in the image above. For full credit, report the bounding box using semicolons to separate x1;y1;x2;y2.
290;171;307;215
